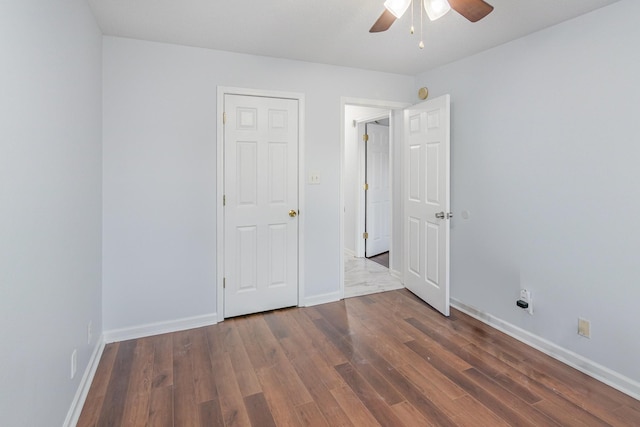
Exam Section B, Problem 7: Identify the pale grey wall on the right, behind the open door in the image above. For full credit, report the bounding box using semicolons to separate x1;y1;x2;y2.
416;0;640;384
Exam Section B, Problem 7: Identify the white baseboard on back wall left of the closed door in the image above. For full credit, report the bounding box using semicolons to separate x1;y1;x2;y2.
104;313;218;344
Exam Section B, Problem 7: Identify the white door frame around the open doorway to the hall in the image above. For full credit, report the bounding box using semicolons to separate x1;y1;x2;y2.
337;96;411;298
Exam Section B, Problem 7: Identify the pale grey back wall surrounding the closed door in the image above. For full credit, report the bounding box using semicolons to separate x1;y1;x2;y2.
103;37;414;330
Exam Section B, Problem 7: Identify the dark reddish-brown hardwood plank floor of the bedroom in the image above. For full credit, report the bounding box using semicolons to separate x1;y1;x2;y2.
78;290;640;427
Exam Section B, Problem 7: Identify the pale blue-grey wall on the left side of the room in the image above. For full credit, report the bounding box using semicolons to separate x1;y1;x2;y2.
0;0;102;426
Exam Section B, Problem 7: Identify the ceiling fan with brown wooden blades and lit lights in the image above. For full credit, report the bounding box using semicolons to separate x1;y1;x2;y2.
369;0;493;33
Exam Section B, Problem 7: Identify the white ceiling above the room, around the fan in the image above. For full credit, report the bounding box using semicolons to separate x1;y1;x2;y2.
89;0;618;75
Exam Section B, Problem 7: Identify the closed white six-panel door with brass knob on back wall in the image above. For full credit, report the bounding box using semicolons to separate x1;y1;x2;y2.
224;94;298;317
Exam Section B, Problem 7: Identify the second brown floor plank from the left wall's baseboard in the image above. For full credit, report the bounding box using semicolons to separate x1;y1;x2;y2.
96;340;137;427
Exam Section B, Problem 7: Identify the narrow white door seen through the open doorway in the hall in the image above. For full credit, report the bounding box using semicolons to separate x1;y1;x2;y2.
365;123;391;257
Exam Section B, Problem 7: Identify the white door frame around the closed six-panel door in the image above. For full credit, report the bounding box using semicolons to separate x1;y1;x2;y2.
216;86;305;322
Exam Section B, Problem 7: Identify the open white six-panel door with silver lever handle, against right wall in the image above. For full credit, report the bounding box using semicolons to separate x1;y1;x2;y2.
404;95;450;316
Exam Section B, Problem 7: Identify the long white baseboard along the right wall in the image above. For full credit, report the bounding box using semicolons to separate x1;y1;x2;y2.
451;298;640;400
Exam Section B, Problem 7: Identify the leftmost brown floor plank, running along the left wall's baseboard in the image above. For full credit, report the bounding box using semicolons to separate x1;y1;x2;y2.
77;343;120;427
